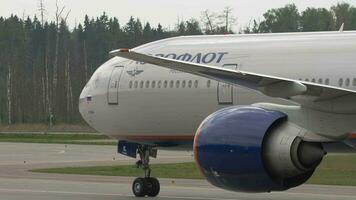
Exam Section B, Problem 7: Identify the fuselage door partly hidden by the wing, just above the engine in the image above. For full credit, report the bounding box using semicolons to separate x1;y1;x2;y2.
218;64;237;104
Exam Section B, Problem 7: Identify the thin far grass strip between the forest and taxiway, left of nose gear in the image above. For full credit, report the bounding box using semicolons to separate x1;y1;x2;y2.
0;133;116;145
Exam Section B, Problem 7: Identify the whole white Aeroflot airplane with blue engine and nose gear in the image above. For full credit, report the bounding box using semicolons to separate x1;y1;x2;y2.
79;31;356;197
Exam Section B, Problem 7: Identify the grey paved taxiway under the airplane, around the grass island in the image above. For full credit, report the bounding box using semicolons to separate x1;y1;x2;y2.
0;143;356;200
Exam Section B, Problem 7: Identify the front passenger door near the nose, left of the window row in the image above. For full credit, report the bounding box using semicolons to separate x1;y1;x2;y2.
108;66;124;105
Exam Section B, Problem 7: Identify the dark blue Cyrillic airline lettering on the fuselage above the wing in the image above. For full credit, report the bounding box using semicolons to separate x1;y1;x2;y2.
136;52;228;64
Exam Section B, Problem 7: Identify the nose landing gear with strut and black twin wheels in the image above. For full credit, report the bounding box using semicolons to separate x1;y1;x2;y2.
132;145;160;197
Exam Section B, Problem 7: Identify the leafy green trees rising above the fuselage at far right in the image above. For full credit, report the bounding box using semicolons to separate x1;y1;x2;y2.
242;3;356;33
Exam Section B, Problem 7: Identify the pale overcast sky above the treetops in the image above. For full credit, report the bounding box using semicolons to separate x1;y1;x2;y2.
0;0;356;31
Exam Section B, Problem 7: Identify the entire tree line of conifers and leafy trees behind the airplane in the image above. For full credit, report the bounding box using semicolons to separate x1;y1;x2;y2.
0;3;356;124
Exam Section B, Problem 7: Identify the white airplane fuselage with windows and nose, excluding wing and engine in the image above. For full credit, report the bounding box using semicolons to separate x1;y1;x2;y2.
80;32;356;144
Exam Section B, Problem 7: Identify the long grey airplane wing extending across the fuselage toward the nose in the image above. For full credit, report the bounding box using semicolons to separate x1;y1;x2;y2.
110;49;356;102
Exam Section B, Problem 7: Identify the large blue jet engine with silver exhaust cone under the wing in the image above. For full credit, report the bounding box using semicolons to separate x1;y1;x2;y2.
194;106;324;192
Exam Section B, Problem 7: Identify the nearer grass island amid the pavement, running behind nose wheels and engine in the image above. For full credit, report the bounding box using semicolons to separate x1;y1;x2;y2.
31;154;356;186
